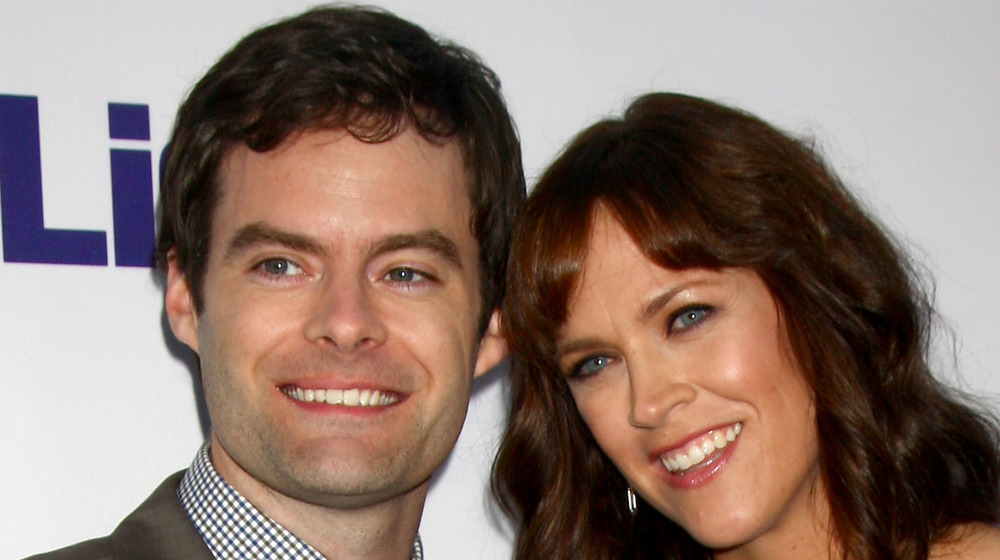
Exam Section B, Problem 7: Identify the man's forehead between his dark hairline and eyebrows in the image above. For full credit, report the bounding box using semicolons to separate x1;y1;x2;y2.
212;130;475;255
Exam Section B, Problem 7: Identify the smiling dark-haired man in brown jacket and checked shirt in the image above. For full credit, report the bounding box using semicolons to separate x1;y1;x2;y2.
26;8;524;559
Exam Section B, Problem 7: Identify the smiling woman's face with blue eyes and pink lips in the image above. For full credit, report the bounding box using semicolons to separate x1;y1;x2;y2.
557;210;825;550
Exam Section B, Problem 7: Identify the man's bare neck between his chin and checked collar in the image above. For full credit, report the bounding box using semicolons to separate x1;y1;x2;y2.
211;439;429;560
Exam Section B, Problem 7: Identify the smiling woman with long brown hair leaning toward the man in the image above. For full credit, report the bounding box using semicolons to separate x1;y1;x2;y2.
493;94;1000;560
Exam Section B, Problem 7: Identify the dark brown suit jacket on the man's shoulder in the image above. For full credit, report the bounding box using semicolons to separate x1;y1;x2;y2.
25;471;212;560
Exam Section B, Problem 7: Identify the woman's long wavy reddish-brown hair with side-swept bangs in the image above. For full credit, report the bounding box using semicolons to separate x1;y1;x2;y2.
493;94;1000;560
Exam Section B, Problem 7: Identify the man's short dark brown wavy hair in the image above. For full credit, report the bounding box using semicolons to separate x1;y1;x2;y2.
156;6;525;326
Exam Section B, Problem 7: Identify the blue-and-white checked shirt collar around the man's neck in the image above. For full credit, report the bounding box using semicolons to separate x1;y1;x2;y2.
177;442;424;560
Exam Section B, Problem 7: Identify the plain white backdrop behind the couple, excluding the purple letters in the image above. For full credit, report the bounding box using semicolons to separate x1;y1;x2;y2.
0;0;1000;559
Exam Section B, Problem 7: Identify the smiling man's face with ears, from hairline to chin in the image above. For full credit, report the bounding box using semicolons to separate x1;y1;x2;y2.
166;131;503;507
